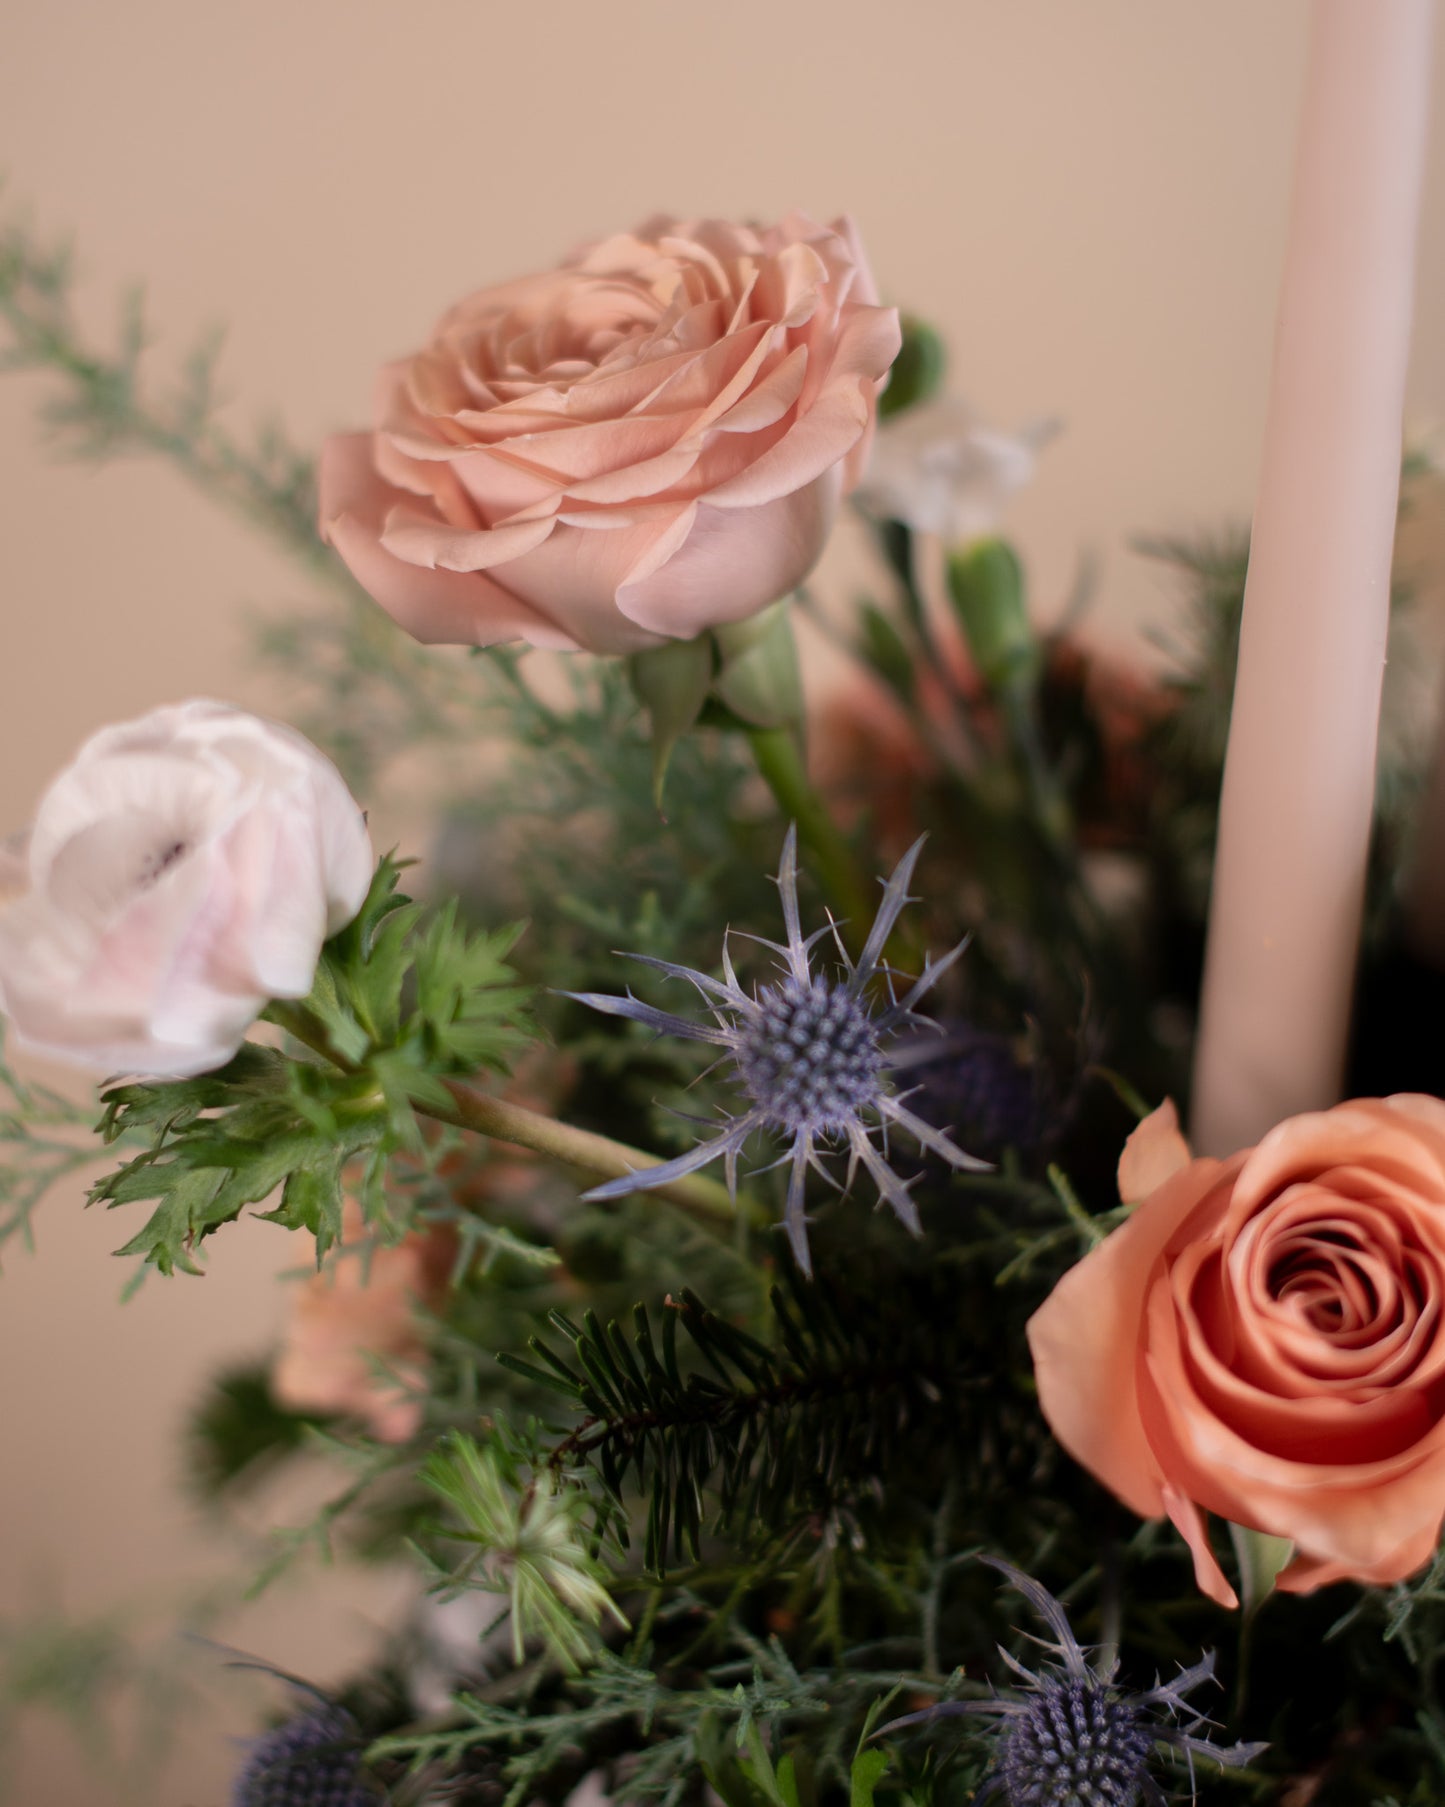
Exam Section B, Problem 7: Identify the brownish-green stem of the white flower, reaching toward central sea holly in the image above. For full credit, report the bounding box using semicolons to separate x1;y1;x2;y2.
266;1003;751;1225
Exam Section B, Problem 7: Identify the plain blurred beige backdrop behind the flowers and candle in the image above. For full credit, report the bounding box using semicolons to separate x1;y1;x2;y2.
0;0;1445;1807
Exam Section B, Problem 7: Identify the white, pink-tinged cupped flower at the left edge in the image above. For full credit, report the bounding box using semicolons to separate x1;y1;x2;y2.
0;699;376;1079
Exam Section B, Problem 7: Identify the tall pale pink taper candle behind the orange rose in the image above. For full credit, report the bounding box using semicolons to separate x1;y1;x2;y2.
1192;0;1432;1155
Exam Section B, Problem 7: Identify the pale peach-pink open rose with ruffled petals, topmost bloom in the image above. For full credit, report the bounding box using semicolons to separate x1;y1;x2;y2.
320;213;900;652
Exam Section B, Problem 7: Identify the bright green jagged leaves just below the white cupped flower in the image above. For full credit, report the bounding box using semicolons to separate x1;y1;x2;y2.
90;857;529;1274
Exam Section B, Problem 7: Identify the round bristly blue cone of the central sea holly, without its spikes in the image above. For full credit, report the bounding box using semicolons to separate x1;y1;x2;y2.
737;978;883;1133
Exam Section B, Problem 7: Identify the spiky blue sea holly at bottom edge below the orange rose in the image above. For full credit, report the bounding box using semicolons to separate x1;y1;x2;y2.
878;1556;1266;1807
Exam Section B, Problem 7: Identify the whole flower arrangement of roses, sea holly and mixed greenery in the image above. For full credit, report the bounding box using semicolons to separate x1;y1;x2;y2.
0;9;1445;1807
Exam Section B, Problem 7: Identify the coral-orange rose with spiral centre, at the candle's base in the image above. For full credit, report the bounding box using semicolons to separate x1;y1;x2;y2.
1028;1095;1445;1606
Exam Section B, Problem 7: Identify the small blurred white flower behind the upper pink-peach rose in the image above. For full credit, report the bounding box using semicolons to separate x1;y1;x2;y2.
856;396;1058;542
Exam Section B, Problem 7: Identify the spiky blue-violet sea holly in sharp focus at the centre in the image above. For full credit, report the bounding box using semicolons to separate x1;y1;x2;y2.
567;828;988;1274
